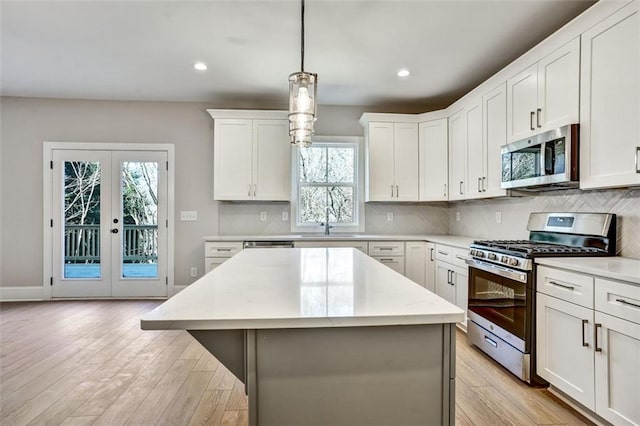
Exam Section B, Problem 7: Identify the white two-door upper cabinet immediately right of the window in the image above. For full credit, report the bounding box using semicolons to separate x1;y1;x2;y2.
365;122;418;201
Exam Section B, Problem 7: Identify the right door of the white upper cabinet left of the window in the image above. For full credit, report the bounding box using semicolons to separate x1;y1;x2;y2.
253;120;291;201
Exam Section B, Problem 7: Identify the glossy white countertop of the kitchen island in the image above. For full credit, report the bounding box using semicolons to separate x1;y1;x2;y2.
141;248;464;330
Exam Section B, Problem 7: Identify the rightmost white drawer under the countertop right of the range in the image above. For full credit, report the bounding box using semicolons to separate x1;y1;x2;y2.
595;278;640;324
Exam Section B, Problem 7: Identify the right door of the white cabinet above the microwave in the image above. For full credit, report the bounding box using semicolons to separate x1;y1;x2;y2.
536;38;580;132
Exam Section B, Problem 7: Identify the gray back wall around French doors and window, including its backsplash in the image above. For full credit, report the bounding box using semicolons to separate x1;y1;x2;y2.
0;97;447;287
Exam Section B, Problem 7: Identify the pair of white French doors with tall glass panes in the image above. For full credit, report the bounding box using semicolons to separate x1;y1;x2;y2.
51;149;168;298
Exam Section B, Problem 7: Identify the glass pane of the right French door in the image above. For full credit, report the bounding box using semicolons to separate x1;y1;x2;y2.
120;161;158;278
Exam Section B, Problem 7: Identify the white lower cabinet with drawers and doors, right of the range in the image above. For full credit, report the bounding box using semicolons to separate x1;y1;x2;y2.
536;268;640;425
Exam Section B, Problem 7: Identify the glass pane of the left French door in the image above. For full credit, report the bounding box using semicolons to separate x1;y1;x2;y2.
63;161;102;279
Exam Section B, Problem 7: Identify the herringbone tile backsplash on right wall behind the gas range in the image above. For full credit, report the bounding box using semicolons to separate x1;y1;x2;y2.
449;189;640;259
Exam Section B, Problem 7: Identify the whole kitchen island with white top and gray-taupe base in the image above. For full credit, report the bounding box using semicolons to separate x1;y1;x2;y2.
141;248;464;425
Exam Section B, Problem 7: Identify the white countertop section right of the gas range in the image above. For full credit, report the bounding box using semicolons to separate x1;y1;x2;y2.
536;257;640;285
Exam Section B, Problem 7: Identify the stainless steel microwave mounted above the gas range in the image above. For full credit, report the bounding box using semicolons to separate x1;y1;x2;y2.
500;124;580;189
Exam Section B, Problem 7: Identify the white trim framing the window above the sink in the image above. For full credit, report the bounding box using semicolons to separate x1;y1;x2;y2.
290;136;364;235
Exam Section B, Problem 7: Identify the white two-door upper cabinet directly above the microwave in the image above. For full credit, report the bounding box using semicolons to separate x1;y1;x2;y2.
507;38;580;141
